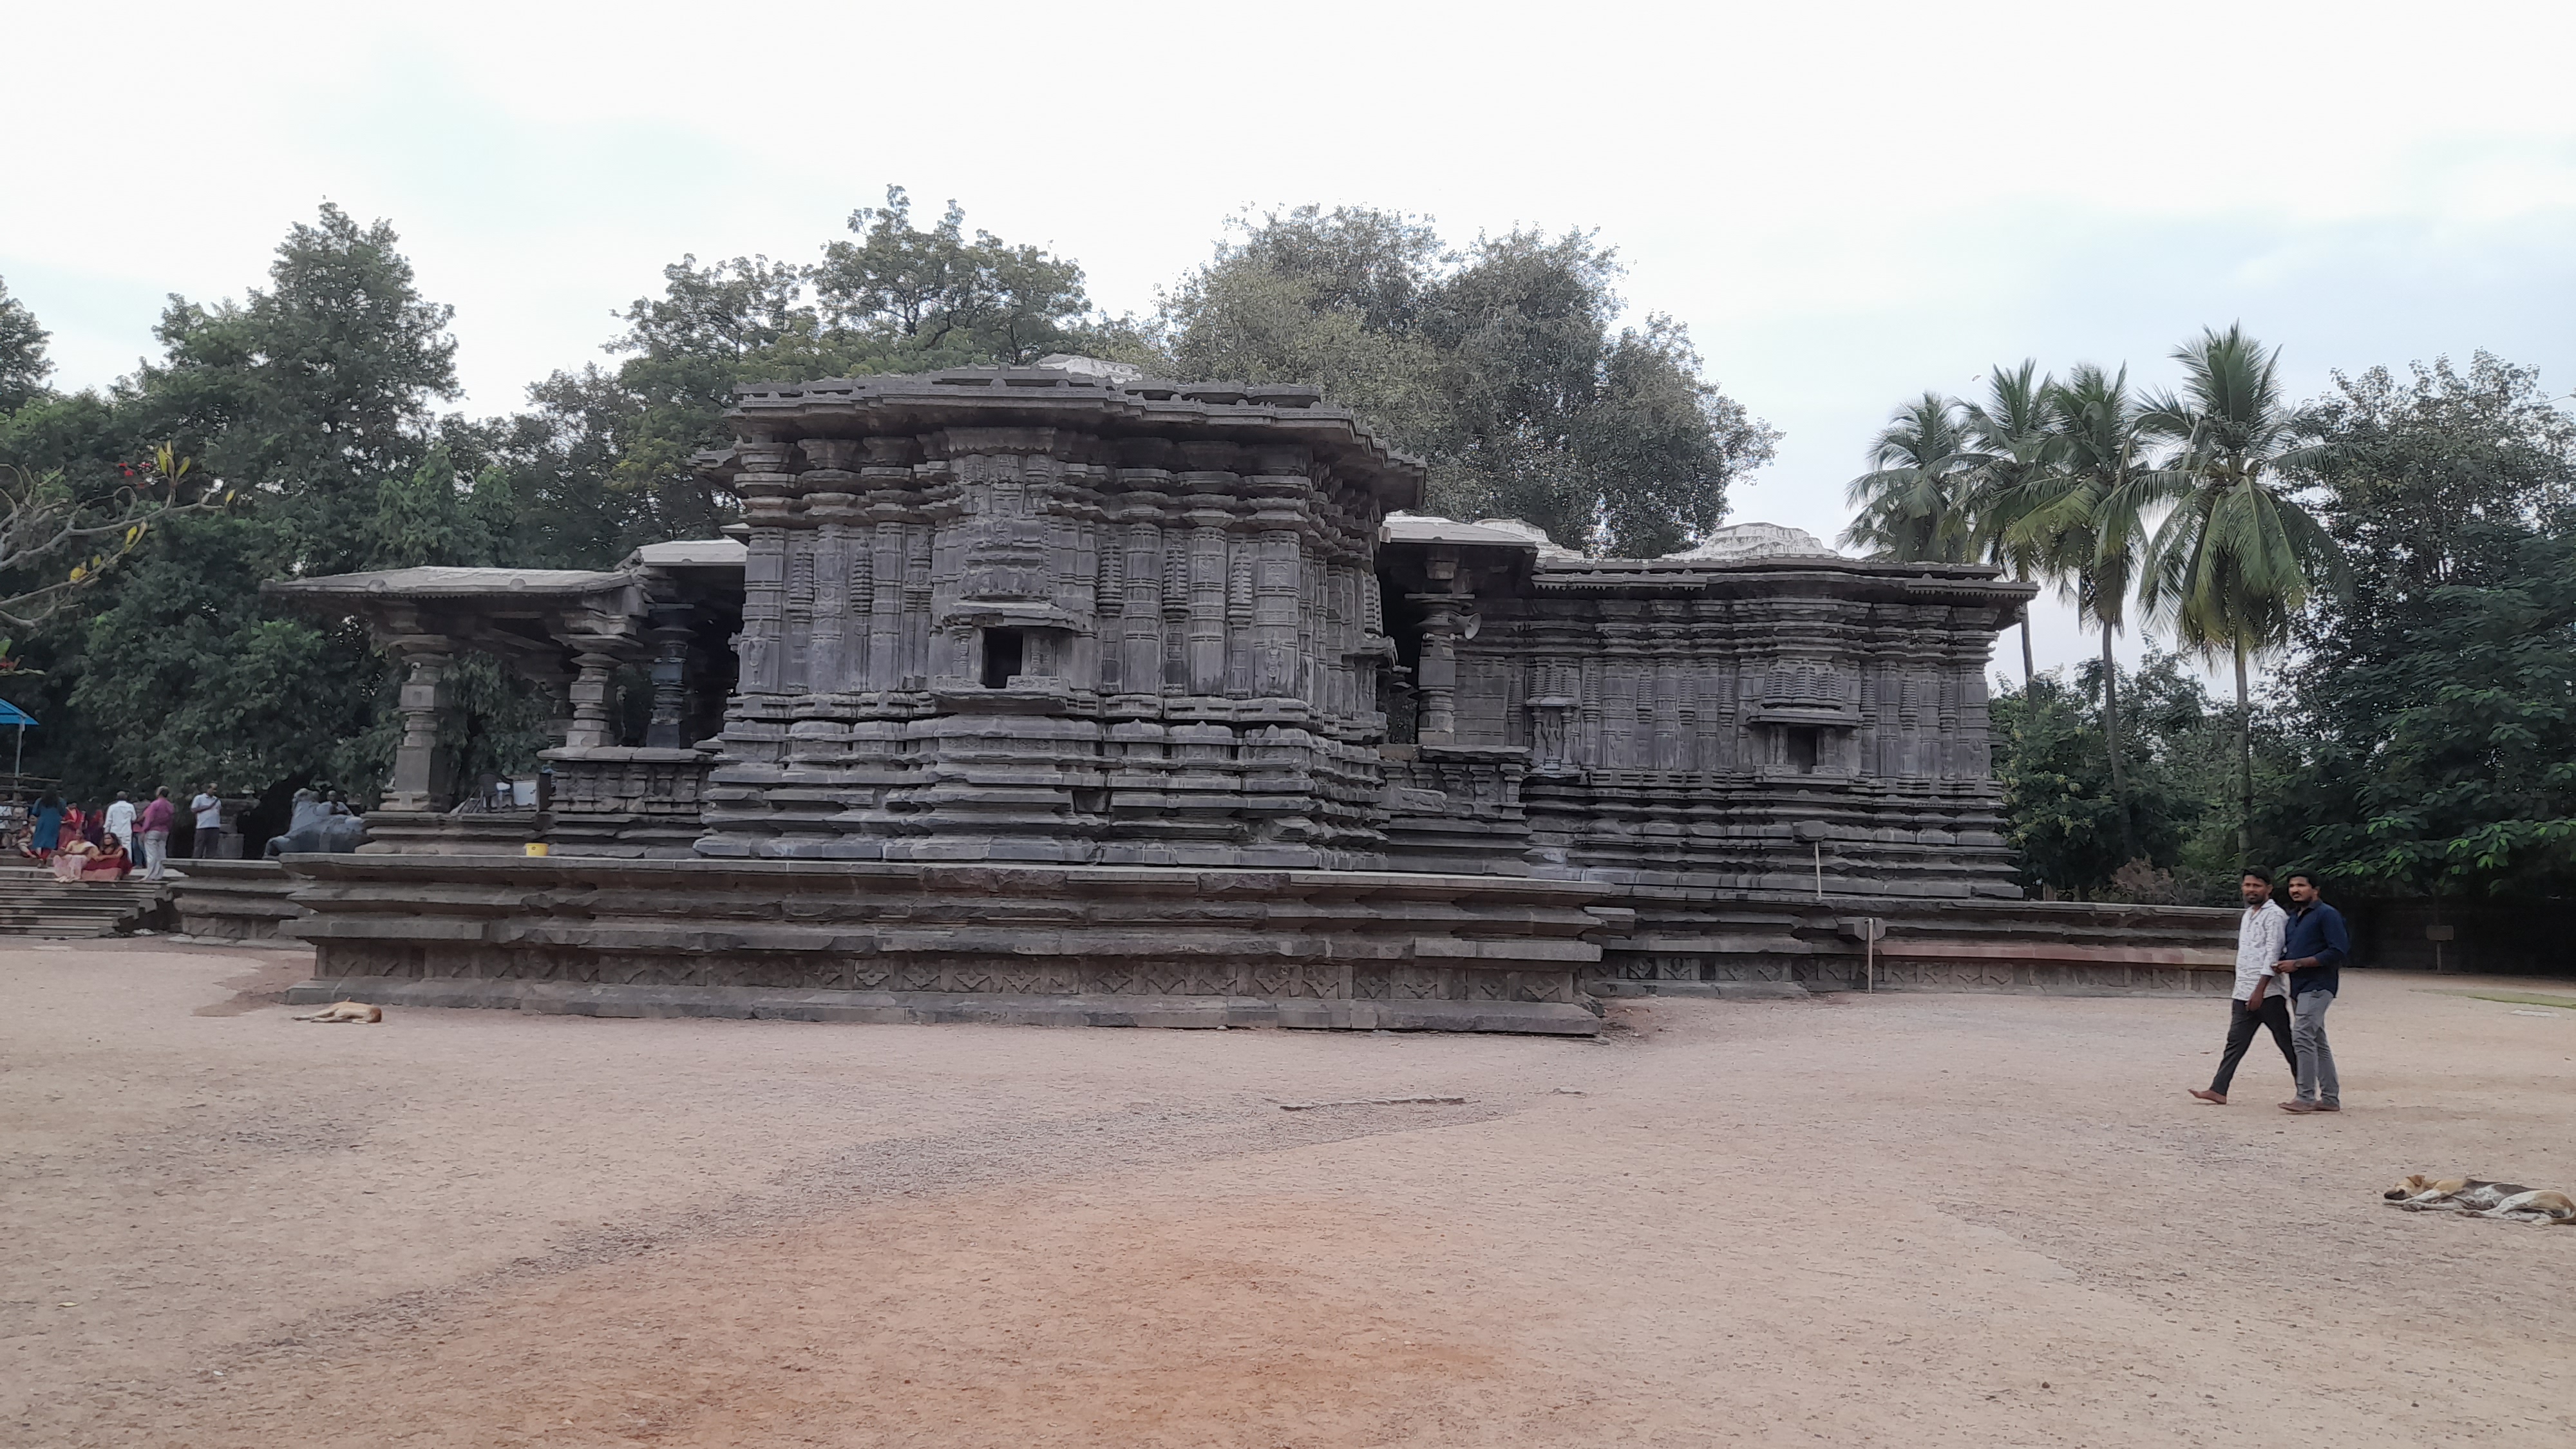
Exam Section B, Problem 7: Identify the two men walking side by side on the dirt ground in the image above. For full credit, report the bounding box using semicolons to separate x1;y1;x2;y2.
2192;869;2352;1114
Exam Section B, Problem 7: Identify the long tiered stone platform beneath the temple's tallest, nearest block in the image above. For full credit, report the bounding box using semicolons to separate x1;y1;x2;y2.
283;856;1631;1036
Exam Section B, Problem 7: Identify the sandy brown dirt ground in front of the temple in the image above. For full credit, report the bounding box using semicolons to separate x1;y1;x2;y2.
0;941;2576;1449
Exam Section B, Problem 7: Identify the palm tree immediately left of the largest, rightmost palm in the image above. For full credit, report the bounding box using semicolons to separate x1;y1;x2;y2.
2012;364;2156;853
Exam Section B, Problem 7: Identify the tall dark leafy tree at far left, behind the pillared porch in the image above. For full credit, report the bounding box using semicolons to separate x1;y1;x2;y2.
13;206;456;789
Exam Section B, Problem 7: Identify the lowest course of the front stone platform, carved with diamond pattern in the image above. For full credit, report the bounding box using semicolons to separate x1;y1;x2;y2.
286;977;1602;1036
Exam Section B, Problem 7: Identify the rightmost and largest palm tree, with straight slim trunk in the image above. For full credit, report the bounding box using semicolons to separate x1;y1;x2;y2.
2138;325;2342;856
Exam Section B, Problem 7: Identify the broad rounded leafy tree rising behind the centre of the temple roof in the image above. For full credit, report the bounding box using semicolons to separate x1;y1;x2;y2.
1159;206;1777;554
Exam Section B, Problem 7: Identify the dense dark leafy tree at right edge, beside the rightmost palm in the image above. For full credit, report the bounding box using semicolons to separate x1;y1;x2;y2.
2272;353;2576;895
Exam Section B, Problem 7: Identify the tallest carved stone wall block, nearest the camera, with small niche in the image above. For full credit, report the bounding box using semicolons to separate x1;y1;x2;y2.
698;369;1419;866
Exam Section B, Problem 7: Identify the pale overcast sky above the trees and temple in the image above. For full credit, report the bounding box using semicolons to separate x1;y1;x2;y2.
0;0;2576;668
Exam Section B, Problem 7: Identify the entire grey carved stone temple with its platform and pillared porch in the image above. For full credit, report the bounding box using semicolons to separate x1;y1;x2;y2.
216;369;2233;1034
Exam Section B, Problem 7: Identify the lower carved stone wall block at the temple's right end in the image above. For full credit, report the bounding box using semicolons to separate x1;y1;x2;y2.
1391;541;2027;897
